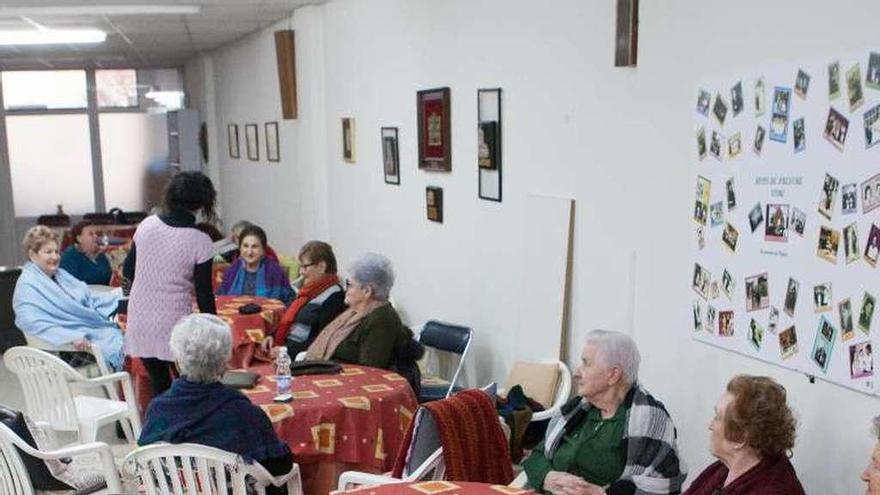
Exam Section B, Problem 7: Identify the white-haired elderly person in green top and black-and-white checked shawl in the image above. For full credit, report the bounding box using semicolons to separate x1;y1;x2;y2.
523;330;686;495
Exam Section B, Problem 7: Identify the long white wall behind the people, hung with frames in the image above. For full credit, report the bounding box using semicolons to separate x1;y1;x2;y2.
198;0;880;494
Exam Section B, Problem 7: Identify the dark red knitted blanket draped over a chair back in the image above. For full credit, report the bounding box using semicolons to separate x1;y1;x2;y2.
393;389;513;485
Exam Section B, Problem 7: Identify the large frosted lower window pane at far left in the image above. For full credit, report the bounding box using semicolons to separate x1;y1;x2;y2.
6;114;95;217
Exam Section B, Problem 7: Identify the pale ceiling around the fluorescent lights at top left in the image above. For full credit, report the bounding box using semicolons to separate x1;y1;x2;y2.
0;0;326;70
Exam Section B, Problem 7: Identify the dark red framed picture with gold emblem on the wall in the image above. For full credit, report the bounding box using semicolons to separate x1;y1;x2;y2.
416;88;452;172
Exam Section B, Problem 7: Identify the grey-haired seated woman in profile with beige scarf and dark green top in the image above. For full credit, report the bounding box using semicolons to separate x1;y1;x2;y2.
307;253;423;392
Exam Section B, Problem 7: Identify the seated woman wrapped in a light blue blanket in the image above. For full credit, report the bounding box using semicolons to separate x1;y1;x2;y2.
12;225;123;370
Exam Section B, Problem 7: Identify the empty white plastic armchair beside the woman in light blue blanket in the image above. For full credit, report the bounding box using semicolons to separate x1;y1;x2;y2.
3;346;141;443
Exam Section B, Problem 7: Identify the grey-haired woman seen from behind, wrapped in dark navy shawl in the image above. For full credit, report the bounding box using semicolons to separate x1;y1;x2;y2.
138;313;293;488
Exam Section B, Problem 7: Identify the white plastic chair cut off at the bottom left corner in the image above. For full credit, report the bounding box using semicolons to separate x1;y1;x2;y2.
0;423;122;495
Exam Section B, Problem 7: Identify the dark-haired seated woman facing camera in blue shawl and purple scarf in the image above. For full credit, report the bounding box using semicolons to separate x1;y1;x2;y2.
217;225;293;304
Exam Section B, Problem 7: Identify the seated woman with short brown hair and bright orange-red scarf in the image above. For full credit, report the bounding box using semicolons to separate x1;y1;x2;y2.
263;241;345;357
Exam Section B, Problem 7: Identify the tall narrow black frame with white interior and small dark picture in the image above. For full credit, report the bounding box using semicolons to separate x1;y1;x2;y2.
477;88;501;202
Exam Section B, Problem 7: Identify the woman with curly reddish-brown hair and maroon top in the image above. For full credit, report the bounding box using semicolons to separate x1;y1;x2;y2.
685;375;804;495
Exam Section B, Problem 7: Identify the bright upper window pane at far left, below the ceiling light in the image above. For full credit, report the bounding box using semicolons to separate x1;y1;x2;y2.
2;70;86;110
